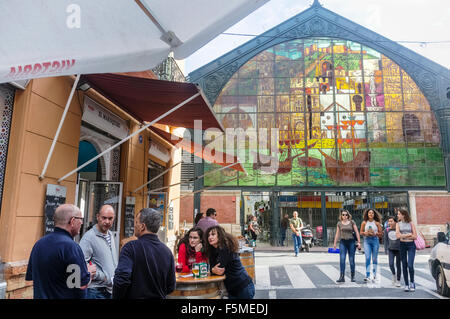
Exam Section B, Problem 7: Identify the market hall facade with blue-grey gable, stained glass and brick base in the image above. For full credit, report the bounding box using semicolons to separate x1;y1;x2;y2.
180;1;450;245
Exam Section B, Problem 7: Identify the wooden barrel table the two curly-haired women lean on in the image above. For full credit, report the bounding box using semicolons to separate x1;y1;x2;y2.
167;273;225;299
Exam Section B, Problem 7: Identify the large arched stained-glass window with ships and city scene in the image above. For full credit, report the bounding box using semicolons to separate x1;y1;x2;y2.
205;38;445;187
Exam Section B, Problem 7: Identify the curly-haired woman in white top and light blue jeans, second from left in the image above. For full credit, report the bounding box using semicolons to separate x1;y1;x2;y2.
360;208;383;282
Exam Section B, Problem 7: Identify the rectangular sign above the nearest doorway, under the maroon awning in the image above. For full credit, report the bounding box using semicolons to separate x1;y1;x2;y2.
82;96;128;140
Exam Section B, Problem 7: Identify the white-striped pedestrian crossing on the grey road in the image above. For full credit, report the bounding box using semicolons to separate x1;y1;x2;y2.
255;264;436;291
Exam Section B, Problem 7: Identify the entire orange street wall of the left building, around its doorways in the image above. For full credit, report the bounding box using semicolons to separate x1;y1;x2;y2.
0;77;180;298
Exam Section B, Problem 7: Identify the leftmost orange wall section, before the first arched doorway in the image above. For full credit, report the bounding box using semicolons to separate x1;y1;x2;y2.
0;77;81;298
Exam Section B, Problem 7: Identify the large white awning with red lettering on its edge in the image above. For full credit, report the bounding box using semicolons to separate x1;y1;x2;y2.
0;0;269;83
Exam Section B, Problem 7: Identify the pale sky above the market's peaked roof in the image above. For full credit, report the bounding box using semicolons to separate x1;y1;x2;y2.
184;0;450;75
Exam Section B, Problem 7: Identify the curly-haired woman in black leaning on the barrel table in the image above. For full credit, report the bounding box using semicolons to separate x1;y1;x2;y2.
204;226;255;299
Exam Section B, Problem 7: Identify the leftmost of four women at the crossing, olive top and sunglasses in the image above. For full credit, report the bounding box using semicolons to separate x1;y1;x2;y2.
333;209;361;282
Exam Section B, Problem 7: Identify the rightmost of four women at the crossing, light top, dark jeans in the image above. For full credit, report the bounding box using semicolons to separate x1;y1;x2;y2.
396;208;417;291
